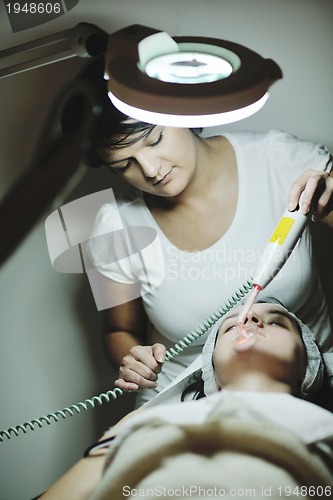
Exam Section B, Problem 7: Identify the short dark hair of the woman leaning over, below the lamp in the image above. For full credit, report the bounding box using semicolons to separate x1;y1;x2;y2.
62;56;202;167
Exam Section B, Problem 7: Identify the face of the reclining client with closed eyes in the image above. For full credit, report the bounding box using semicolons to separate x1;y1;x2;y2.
213;303;306;391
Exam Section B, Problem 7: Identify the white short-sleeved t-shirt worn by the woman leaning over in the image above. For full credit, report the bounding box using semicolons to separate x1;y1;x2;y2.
90;130;333;400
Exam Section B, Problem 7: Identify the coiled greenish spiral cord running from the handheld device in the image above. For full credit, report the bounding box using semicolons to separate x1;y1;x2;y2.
0;281;252;442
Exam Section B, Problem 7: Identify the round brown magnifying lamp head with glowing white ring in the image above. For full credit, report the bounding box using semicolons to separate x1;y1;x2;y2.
105;25;282;128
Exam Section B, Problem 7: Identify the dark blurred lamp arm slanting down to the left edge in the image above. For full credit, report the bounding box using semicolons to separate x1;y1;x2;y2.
0;82;100;267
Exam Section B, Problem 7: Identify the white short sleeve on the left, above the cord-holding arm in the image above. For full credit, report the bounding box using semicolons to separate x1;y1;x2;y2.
84;198;165;310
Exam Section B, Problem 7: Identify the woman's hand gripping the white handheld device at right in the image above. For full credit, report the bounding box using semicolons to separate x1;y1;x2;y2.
288;169;333;219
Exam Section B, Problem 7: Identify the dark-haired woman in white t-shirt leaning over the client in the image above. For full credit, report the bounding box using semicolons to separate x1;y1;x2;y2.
64;57;333;405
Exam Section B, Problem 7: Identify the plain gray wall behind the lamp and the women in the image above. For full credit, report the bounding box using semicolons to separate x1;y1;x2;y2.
0;0;333;500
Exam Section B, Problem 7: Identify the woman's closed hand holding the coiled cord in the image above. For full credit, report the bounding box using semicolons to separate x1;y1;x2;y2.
115;344;166;391
